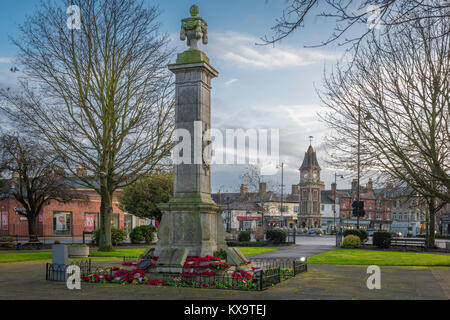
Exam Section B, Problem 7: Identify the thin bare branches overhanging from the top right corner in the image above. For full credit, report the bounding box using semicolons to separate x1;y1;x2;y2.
262;0;450;51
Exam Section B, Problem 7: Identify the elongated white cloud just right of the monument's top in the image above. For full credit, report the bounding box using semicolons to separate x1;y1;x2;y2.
209;32;339;70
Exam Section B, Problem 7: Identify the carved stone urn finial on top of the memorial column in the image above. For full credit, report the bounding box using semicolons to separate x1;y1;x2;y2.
180;4;208;49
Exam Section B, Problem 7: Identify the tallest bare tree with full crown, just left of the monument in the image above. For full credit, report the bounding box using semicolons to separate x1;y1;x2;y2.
0;0;174;250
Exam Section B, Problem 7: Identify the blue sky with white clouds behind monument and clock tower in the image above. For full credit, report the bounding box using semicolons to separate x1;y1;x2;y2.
0;0;366;192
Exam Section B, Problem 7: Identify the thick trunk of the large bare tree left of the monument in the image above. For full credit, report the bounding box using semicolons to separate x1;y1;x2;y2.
98;186;113;251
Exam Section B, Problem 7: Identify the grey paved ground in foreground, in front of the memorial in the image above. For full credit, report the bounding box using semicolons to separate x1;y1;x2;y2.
0;262;450;300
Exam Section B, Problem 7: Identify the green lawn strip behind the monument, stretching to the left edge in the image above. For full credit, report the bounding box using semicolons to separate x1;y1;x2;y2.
0;247;278;263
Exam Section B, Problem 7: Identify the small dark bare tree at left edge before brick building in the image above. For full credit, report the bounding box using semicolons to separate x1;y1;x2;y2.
0;134;85;241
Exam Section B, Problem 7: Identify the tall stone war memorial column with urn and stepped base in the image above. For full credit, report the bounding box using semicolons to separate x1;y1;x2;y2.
155;6;247;273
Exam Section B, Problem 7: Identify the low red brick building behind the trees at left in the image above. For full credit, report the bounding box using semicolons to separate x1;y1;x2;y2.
0;188;125;237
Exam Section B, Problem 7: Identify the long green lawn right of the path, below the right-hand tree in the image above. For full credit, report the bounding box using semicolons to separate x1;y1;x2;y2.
308;250;450;266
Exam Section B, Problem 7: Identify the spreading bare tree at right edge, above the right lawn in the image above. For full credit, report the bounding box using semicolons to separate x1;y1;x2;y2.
321;17;450;245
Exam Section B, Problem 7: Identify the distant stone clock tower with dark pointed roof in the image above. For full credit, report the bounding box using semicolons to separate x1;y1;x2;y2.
298;145;325;228
